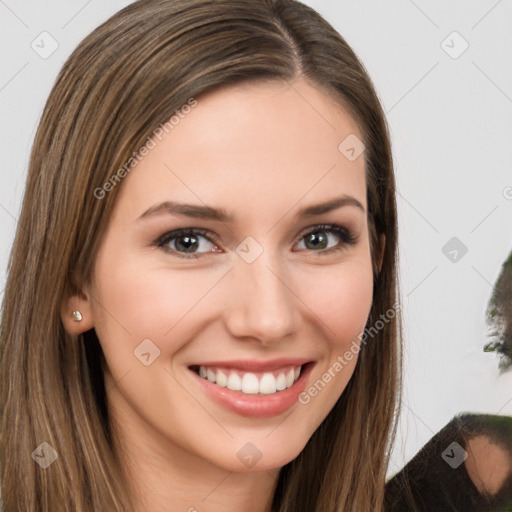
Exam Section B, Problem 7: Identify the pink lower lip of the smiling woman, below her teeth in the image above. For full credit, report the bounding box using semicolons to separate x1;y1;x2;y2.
190;362;314;418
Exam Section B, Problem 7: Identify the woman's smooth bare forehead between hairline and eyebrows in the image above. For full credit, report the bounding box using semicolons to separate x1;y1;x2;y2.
110;79;366;222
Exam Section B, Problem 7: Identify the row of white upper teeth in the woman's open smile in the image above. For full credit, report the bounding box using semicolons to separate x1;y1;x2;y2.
195;366;301;395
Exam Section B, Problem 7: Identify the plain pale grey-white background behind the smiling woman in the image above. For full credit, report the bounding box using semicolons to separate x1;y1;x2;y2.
0;0;512;475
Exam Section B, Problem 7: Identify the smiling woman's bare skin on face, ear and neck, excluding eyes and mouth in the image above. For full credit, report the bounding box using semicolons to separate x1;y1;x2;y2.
62;78;384;512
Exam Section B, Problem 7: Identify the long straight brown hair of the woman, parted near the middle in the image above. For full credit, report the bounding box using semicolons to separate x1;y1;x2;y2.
0;0;402;512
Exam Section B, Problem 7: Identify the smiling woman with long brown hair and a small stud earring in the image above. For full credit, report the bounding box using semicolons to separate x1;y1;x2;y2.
0;0;401;512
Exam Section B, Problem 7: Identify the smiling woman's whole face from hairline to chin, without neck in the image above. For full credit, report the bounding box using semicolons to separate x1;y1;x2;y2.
80;79;373;471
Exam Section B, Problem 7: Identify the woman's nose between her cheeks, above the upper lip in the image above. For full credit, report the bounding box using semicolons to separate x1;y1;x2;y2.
224;251;300;345
